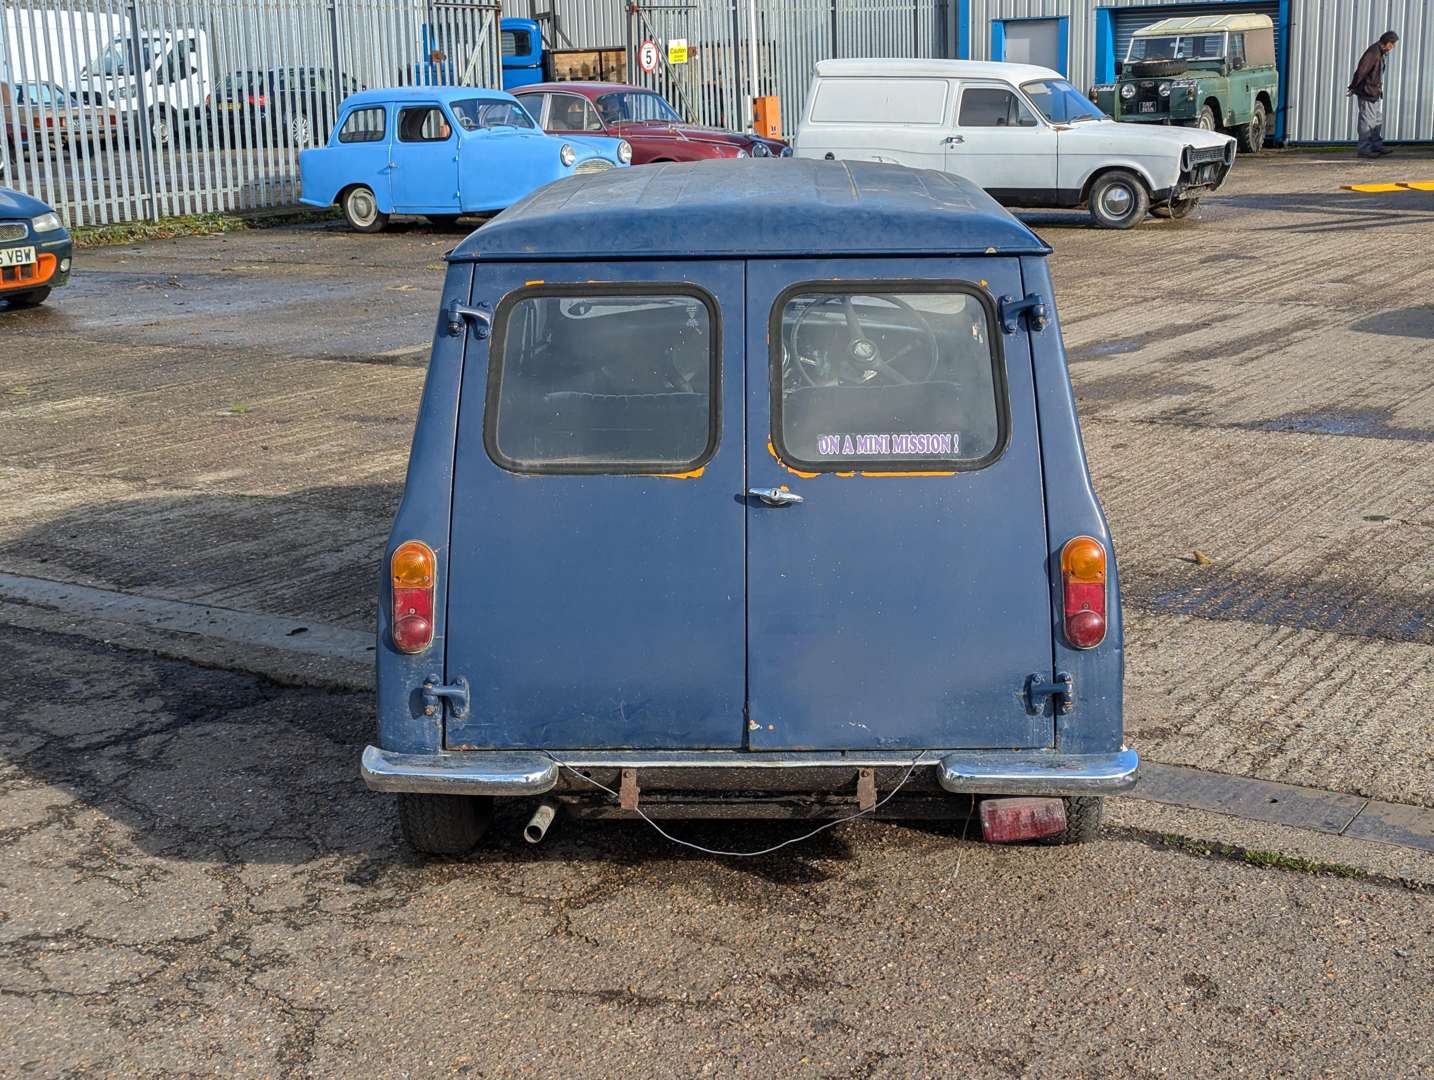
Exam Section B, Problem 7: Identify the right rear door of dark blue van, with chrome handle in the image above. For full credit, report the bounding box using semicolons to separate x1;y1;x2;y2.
747;258;1054;750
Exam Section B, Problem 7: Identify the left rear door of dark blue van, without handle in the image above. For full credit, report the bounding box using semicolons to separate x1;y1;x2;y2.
439;260;746;750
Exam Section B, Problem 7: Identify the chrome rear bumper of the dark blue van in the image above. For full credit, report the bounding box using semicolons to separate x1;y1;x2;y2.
361;746;1140;796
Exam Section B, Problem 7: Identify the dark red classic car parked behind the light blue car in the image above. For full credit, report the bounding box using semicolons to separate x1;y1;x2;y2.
513;83;792;165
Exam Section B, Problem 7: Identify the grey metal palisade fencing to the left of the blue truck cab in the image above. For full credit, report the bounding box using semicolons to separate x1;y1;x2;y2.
0;0;502;225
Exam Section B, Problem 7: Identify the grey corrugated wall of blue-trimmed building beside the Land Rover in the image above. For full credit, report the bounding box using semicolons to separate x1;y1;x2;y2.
971;0;1434;142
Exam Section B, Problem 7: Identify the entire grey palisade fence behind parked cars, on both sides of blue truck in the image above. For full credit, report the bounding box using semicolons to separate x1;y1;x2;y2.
0;0;956;225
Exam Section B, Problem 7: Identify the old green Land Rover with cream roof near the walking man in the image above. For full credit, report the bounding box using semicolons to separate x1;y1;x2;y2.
1090;14;1279;153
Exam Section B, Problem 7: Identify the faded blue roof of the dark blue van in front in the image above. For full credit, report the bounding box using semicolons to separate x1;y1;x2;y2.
449;158;1050;261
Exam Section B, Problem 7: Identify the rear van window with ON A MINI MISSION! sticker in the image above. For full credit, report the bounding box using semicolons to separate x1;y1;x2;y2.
771;285;1008;472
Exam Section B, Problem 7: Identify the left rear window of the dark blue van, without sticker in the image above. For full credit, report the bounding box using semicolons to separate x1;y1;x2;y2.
483;285;720;473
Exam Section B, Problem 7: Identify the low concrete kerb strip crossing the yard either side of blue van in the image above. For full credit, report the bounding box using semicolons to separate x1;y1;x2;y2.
0;572;1434;860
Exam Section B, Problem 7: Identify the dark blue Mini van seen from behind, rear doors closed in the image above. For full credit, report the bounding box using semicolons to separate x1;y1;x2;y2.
363;161;1136;853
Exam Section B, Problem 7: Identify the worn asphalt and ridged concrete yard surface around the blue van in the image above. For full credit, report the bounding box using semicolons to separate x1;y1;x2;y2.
0;153;1434;1077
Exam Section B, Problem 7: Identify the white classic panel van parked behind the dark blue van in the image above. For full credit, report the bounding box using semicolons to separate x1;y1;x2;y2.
794;60;1235;228
